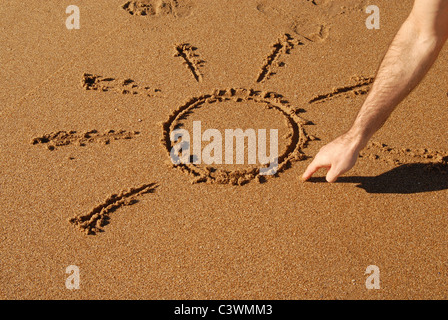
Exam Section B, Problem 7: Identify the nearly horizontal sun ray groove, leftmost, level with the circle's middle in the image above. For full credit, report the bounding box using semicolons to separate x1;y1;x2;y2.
31;130;140;151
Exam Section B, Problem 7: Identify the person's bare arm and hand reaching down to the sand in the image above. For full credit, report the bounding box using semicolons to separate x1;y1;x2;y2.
302;0;448;183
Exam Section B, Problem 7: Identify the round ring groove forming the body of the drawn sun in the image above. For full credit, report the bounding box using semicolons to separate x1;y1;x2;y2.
161;88;310;185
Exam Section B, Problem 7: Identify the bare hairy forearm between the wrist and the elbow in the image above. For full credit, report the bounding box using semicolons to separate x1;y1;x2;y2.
349;17;445;149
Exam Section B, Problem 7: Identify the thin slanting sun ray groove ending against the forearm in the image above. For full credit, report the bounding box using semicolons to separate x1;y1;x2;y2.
308;77;375;104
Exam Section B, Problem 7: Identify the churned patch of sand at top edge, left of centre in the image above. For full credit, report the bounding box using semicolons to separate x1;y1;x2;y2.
121;0;193;18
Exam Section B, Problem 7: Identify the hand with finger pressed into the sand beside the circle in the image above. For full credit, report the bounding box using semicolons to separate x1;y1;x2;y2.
302;133;362;183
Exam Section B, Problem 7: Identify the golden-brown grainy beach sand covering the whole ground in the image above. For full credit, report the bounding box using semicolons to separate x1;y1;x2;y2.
0;0;448;299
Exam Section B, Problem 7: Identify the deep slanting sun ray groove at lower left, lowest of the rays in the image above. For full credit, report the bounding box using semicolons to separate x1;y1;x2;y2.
69;183;157;235
